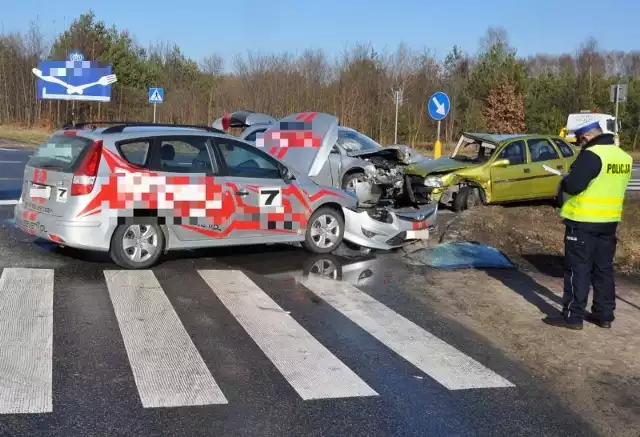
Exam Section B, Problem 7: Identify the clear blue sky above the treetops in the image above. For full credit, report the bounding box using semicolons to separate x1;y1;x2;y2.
0;0;640;66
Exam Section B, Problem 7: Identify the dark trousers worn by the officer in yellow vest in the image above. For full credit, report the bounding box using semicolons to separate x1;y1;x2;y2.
562;224;617;323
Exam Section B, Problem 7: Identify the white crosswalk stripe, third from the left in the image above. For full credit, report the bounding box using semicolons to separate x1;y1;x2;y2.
198;270;378;400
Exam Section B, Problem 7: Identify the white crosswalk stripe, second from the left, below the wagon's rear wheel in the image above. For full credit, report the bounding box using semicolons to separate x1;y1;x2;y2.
104;270;228;408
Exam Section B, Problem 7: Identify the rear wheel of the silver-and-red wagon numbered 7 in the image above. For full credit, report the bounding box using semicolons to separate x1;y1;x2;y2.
109;223;165;270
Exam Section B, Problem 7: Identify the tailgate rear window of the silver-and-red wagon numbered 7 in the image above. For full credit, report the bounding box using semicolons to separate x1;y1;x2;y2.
27;135;93;171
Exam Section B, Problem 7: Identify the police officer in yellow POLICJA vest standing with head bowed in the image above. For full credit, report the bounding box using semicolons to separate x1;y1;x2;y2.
543;122;633;329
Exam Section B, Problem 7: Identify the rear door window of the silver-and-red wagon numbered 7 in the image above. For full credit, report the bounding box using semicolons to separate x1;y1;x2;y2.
151;136;215;174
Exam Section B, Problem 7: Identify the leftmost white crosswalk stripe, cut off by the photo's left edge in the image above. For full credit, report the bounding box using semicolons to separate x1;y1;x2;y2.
0;268;53;414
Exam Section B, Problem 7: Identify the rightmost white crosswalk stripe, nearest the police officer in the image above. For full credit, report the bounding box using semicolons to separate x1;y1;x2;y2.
302;277;514;390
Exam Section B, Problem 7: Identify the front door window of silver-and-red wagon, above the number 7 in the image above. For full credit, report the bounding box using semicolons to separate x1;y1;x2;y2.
216;138;282;179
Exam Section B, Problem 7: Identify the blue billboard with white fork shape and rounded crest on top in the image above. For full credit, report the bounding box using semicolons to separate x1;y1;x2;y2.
31;51;118;102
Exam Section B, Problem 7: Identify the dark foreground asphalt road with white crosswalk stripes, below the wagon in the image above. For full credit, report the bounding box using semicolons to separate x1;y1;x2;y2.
0;206;594;437
